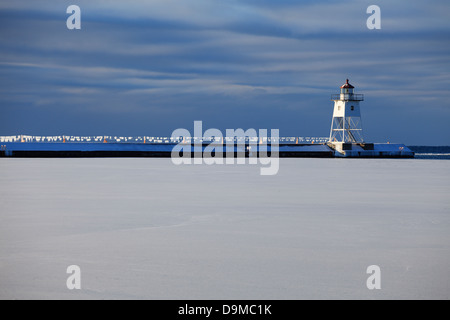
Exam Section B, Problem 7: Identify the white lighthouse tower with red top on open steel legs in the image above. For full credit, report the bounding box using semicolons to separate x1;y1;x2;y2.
329;79;364;146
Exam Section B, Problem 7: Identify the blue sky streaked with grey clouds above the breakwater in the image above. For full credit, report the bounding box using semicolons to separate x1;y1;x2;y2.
0;0;450;145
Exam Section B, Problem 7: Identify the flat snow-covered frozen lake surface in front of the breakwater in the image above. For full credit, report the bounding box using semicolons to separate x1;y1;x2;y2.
0;158;450;299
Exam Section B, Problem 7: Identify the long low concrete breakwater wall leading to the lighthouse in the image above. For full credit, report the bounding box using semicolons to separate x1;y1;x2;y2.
0;142;414;158
